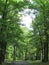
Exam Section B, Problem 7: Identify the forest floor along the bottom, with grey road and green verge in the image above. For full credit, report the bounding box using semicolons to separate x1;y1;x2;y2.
4;61;49;65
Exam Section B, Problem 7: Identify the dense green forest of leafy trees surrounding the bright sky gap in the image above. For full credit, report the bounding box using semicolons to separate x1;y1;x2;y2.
0;0;49;64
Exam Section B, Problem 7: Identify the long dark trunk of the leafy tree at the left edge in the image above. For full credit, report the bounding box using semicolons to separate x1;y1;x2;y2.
0;0;8;64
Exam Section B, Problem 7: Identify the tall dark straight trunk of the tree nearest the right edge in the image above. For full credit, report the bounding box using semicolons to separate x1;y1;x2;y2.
43;6;48;62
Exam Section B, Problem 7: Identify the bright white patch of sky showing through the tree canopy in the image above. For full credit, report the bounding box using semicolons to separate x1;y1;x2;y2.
21;9;35;29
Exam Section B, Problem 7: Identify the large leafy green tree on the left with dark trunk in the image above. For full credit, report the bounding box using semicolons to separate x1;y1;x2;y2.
0;0;28;63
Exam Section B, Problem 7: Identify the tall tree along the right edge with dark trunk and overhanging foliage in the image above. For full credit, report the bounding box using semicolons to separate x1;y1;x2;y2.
29;0;49;62
